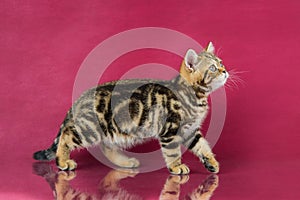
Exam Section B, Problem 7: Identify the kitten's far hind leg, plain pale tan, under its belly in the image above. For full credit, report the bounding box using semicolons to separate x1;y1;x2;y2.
101;143;140;168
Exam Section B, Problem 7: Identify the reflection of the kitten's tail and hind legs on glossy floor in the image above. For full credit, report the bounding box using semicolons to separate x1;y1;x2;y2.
33;162;142;200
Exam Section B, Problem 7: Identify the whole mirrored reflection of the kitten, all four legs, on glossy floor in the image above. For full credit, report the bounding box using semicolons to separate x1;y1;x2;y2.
33;163;219;200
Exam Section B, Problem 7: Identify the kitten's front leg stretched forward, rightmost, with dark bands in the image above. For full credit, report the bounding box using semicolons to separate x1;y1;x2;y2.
184;130;219;173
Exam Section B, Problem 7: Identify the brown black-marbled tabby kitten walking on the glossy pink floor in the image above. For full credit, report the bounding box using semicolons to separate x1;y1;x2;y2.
33;42;229;174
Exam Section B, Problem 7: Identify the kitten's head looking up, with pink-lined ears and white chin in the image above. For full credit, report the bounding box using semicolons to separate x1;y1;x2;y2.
180;42;229;93
